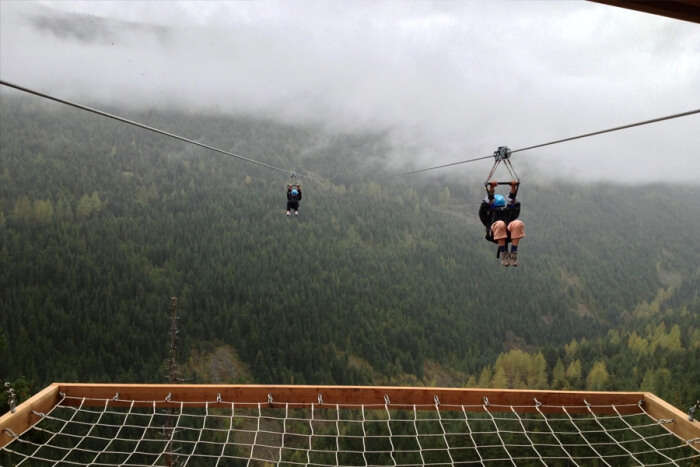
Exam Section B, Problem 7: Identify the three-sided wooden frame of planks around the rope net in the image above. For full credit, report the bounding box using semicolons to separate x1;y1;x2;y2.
0;383;700;449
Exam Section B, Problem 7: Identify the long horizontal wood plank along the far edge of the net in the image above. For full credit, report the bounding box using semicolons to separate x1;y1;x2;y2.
58;383;644;414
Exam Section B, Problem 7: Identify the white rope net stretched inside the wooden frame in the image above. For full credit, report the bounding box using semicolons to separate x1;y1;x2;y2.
0;394;700;467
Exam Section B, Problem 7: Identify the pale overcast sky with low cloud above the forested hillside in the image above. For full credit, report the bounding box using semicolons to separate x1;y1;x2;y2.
0;0;700;182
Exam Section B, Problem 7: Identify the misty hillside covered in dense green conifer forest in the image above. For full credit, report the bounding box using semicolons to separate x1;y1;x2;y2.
0;95;700;408
